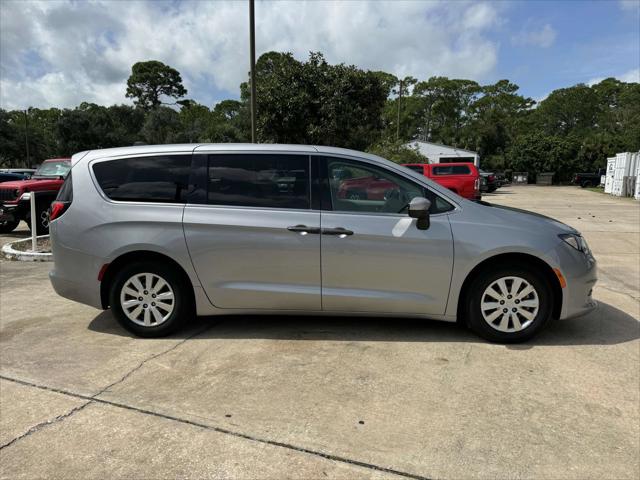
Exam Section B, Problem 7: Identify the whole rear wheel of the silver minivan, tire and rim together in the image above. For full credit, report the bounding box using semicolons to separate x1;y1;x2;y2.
109;262;193;337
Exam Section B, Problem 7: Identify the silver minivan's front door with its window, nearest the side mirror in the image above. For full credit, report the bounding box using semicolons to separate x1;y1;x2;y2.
321;157;453;315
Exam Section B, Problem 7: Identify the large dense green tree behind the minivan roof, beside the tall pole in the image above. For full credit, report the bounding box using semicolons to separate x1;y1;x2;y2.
241;52;387;149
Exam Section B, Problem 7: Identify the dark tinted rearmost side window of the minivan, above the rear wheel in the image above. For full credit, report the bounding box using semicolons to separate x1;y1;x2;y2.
93;155;191;203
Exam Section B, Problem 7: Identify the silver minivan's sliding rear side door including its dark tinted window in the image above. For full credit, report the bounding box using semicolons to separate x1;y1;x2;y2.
183;153;321;310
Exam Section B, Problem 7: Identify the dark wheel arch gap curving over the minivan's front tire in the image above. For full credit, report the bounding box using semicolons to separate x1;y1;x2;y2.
457;252;562;321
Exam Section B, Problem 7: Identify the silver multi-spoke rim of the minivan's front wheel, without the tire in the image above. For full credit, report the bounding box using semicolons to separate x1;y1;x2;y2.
480;277;540;333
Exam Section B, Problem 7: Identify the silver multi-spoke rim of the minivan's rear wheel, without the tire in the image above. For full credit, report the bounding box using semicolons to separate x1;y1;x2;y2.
120;273;175;327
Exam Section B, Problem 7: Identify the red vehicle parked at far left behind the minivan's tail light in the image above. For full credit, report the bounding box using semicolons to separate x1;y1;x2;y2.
0;158;71;234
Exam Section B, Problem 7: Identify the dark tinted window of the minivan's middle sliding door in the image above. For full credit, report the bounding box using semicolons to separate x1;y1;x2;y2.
208;154;310;209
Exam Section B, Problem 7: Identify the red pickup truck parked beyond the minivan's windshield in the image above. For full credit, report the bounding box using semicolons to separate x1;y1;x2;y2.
403;163;481;200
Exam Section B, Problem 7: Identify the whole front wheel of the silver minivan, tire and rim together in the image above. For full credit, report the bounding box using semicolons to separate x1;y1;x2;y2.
467;267;553;343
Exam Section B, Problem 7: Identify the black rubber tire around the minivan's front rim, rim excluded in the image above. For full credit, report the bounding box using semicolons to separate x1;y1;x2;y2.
465;266;553;343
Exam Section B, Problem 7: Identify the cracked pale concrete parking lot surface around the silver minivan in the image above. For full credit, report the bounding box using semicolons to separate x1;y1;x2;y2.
0;187;640;479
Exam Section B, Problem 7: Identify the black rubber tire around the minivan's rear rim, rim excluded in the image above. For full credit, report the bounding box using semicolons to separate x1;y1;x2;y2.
109;261;195;337
